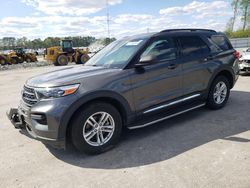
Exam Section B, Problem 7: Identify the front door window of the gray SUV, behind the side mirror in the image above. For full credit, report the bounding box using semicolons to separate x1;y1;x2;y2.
141;38;177;62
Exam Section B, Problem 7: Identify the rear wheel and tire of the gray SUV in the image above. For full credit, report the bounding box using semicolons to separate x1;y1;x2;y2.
207;76;230;110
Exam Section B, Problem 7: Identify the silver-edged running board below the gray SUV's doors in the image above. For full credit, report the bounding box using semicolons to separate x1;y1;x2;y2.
128;103;206;130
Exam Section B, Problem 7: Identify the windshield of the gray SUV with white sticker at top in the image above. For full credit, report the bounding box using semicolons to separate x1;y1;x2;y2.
85;38;146;69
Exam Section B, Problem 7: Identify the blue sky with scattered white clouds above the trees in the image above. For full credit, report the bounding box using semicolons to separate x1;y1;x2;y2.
0;0;232;39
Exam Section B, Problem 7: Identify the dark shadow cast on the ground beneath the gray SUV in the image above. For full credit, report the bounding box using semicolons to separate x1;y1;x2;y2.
35;91;250;169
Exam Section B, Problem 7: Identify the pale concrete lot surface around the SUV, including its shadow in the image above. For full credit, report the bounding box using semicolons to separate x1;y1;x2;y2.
0;66;250;188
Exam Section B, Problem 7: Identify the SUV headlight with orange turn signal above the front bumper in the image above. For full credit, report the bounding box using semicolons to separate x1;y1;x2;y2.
35;84;80;99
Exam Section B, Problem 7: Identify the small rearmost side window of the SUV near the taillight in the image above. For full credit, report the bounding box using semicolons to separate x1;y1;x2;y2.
209;35;232;51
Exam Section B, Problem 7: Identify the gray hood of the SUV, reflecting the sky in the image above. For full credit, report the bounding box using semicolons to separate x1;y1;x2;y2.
26;66;118;87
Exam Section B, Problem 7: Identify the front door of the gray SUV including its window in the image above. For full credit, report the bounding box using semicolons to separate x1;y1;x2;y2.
131;36;182;113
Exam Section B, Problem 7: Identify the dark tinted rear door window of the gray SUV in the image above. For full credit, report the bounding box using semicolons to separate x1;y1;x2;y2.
178;36;210;57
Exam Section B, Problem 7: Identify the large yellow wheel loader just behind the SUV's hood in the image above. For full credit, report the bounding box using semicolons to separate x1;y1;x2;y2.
44;39;89;66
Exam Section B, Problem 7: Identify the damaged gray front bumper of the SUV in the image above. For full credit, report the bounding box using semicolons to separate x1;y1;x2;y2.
7;96;76;149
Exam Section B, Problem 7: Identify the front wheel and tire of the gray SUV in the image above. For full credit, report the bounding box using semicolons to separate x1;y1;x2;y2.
70;102;122;154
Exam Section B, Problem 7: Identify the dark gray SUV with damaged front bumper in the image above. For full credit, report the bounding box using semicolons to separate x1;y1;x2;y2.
8;29;239;154
